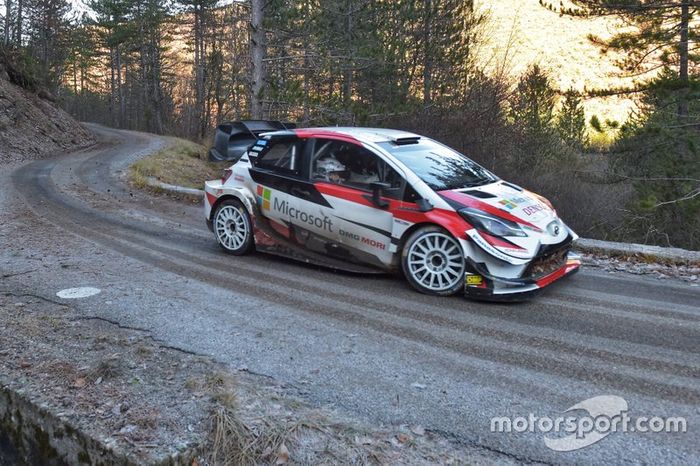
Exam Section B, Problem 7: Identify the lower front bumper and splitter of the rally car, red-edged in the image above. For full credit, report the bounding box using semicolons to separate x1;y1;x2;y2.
464;252;581;301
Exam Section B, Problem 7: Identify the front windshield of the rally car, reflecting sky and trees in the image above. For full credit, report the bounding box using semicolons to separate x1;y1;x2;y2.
379;138;498;191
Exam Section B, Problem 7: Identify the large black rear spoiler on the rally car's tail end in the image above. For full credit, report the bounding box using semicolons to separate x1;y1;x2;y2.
209;120;296;162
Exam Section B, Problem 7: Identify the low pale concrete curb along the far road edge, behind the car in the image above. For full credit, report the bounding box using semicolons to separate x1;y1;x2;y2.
146;177;700;265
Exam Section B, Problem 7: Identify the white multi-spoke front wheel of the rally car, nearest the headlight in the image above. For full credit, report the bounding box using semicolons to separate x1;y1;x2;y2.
401;226;464;296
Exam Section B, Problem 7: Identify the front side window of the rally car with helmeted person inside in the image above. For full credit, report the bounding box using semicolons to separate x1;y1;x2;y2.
311;139;403;197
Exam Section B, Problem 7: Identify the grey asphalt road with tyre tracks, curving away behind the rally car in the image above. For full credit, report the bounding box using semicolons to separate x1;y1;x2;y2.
0;127;700;464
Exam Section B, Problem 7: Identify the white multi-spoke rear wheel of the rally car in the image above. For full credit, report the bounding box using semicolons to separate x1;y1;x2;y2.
213;199;255;256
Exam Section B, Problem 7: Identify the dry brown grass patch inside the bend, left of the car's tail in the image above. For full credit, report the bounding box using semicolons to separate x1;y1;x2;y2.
129;138;226;189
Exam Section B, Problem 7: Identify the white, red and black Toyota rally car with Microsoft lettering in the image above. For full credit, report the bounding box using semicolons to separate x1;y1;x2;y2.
204;123;581;300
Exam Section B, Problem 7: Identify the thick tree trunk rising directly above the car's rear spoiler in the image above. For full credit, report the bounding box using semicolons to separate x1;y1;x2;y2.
250;0;266;120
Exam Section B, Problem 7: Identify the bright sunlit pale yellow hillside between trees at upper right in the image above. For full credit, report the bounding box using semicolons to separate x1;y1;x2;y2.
476;0;633;122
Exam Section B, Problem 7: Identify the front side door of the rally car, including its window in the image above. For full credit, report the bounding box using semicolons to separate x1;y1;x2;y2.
310;138;404;266
